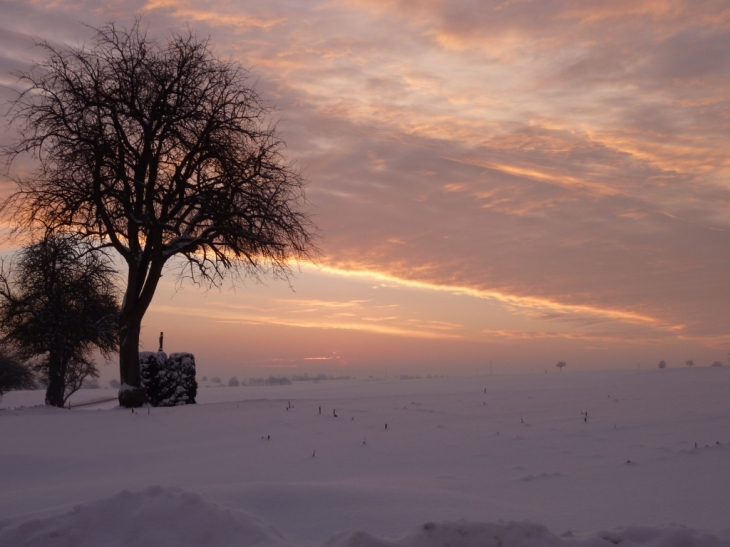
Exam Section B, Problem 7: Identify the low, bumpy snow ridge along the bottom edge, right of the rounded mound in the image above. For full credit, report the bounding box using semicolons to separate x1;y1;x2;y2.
325;521;730;547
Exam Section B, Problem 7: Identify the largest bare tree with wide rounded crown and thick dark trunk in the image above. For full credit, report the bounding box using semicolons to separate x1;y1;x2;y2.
5;22;315;406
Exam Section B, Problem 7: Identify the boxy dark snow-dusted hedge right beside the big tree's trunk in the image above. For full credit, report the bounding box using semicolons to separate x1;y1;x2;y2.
139;351;198;406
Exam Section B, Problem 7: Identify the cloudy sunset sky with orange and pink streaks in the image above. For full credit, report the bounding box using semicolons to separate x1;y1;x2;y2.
0;0;730;377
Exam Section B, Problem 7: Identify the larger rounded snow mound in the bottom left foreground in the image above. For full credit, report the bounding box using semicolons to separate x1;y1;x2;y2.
0;486;287;547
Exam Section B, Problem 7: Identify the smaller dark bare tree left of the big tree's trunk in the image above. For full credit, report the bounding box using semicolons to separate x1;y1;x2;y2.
0;235;119;407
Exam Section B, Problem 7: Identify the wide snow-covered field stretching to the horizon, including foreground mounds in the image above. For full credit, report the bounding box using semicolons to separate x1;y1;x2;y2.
0;367;730;547
